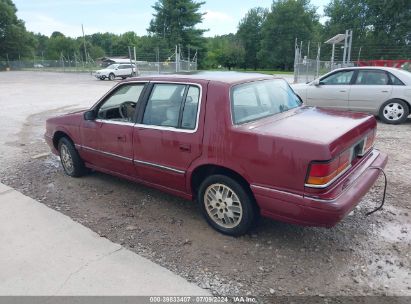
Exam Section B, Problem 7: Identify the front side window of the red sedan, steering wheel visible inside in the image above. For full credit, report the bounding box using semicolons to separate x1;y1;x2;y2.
97;83;144;122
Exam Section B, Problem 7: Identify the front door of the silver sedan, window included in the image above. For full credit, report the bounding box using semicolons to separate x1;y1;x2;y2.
305;70;354;110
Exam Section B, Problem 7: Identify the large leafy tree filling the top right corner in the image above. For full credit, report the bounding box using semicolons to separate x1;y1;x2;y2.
324;0;411;59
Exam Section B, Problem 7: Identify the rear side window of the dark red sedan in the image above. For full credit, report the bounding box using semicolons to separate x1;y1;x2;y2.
143;83;200;130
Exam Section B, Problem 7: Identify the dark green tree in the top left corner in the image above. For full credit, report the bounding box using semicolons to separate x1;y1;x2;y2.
0;0;35;59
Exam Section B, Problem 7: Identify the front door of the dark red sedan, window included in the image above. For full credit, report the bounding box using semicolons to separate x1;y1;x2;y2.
81;82;145;176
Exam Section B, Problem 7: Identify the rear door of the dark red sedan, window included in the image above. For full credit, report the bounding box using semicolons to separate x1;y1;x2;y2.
133;83;205;192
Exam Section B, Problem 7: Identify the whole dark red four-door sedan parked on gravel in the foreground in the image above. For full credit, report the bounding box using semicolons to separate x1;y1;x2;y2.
45;73;387;235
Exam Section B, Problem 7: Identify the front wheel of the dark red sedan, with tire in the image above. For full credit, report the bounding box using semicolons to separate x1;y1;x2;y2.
58;137;86;177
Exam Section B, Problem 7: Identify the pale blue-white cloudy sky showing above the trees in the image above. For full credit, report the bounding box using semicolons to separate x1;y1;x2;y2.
13;0;329;37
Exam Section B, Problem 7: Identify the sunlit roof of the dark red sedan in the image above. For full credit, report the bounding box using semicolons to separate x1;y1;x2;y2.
130;72;274;84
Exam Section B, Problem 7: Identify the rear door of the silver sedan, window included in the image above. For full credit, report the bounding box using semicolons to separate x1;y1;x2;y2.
349;69;392;114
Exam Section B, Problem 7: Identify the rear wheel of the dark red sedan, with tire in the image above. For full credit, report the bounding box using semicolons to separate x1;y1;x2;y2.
198;175;257;236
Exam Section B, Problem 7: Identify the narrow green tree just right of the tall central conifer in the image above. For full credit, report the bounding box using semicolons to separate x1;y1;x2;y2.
237;7;268;70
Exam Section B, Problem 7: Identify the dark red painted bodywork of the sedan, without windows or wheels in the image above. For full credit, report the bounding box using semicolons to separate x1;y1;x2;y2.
45;73;387;227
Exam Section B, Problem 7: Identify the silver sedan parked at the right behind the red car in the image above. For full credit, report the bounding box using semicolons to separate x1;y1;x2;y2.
292;67;411;124
